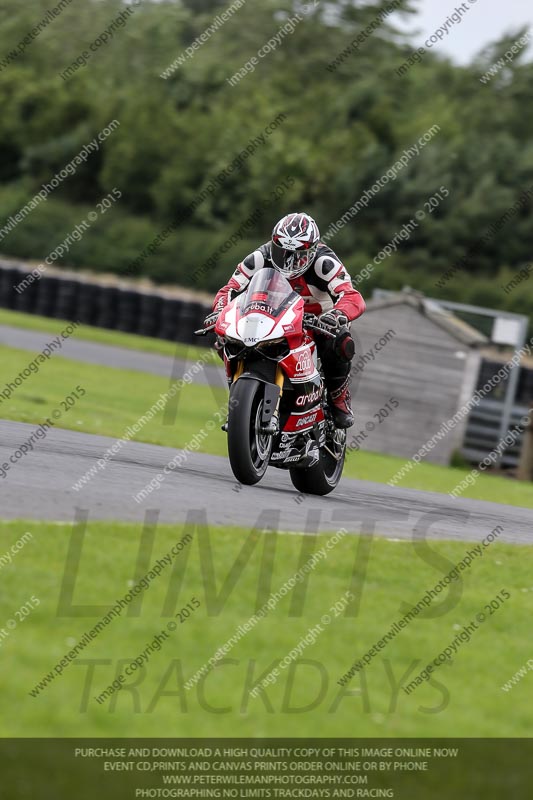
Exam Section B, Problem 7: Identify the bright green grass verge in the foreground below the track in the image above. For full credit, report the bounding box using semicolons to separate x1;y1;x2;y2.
0;522;533;737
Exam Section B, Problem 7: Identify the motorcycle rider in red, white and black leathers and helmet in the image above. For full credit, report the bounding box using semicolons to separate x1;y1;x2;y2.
206;212;365;428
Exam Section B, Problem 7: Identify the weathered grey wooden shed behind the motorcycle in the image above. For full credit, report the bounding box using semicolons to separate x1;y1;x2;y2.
348;290;487;465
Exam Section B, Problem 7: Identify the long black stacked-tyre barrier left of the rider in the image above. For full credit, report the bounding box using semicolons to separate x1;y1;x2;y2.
0;261;212;346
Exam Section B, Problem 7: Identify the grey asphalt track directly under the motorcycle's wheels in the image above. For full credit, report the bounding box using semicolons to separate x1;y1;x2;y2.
0;421;533;544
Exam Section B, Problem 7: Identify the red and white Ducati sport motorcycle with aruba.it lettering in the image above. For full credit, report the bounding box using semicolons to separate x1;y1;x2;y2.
195;268;346;495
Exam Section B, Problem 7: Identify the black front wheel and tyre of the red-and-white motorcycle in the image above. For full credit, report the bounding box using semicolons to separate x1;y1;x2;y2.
228;378;274;486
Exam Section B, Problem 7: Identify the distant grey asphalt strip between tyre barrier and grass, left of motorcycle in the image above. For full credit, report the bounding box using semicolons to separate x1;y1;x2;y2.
0;323;222;386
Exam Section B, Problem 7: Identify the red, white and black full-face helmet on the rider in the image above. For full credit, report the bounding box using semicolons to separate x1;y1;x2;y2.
271;213;320;278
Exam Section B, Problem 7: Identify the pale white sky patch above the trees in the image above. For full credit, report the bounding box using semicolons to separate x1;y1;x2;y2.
391;0;533;64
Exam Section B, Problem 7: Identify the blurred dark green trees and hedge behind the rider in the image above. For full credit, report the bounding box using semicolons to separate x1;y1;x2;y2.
0;0;533;324
